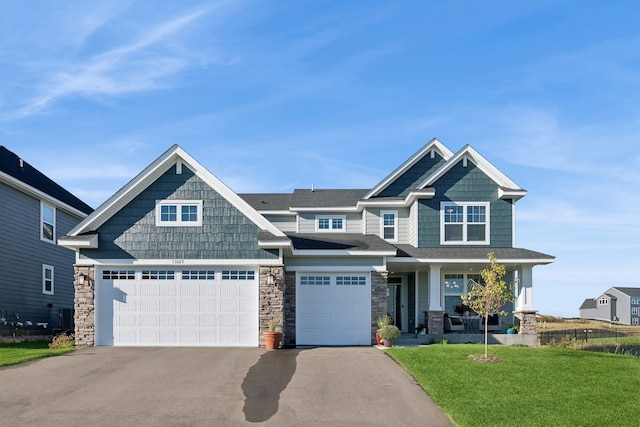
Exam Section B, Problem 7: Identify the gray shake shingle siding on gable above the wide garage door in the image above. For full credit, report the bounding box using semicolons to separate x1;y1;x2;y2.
81;166;277;259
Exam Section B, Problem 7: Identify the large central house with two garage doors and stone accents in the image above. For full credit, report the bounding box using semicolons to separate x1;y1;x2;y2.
60;139;554;346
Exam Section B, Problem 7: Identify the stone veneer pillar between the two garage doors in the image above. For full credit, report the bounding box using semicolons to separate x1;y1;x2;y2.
259;265;287;347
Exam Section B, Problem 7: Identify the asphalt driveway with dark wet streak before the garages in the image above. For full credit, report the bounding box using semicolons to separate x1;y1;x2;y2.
0;347;452;426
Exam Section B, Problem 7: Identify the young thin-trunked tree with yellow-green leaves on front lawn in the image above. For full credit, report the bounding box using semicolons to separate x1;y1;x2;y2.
462;252;515;359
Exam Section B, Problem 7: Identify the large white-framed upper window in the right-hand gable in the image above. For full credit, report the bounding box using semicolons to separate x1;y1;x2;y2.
440;202;489;244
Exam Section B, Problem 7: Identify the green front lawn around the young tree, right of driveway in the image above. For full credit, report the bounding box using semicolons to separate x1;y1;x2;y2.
387;344;640;427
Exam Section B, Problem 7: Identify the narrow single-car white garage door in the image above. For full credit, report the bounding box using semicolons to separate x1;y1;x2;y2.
296;273;371;345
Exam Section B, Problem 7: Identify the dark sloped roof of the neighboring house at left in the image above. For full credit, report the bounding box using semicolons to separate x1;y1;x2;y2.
0;145;93;217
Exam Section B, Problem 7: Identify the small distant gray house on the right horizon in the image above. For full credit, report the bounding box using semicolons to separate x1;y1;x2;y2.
580;286;640;325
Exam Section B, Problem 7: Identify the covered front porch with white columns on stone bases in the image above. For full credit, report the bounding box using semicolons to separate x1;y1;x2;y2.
387;245;554;345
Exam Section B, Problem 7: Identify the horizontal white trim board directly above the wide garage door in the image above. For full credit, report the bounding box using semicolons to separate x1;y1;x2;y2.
76;258;282;269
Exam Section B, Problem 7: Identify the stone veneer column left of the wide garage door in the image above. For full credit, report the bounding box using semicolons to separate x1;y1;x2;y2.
73;265;96;347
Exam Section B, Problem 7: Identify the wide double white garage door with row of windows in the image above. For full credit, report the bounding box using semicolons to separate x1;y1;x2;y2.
96;267;259;346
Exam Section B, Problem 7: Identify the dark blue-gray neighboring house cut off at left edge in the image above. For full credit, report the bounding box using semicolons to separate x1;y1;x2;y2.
0;146;93;329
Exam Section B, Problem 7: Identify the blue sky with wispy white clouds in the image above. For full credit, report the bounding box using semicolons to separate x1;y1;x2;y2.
0;0;640;316
